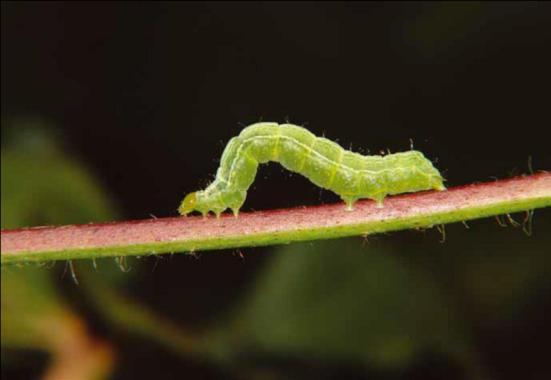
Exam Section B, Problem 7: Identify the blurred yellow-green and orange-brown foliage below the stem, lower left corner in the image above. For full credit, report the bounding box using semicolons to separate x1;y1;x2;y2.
2;267;114;380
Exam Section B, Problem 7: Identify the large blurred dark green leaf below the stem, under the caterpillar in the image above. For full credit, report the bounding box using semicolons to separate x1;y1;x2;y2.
209;240;476;368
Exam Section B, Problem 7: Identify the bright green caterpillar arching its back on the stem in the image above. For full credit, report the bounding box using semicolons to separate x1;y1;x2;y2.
178;123;445;216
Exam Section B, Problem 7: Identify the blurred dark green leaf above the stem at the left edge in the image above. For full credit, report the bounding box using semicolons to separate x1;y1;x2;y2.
2;121;115;228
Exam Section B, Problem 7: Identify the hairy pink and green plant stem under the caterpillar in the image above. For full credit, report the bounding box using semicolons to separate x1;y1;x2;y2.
1;172;551;264
